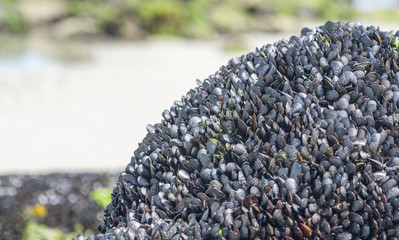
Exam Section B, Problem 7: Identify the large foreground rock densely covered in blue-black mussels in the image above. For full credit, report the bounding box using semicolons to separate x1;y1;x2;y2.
79;22;399;239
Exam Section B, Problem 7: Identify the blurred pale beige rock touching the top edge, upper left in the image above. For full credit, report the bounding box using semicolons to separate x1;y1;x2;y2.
18;0;68;26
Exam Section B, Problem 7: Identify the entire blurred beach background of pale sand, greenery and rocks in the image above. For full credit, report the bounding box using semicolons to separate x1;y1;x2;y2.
0;0;399;239
